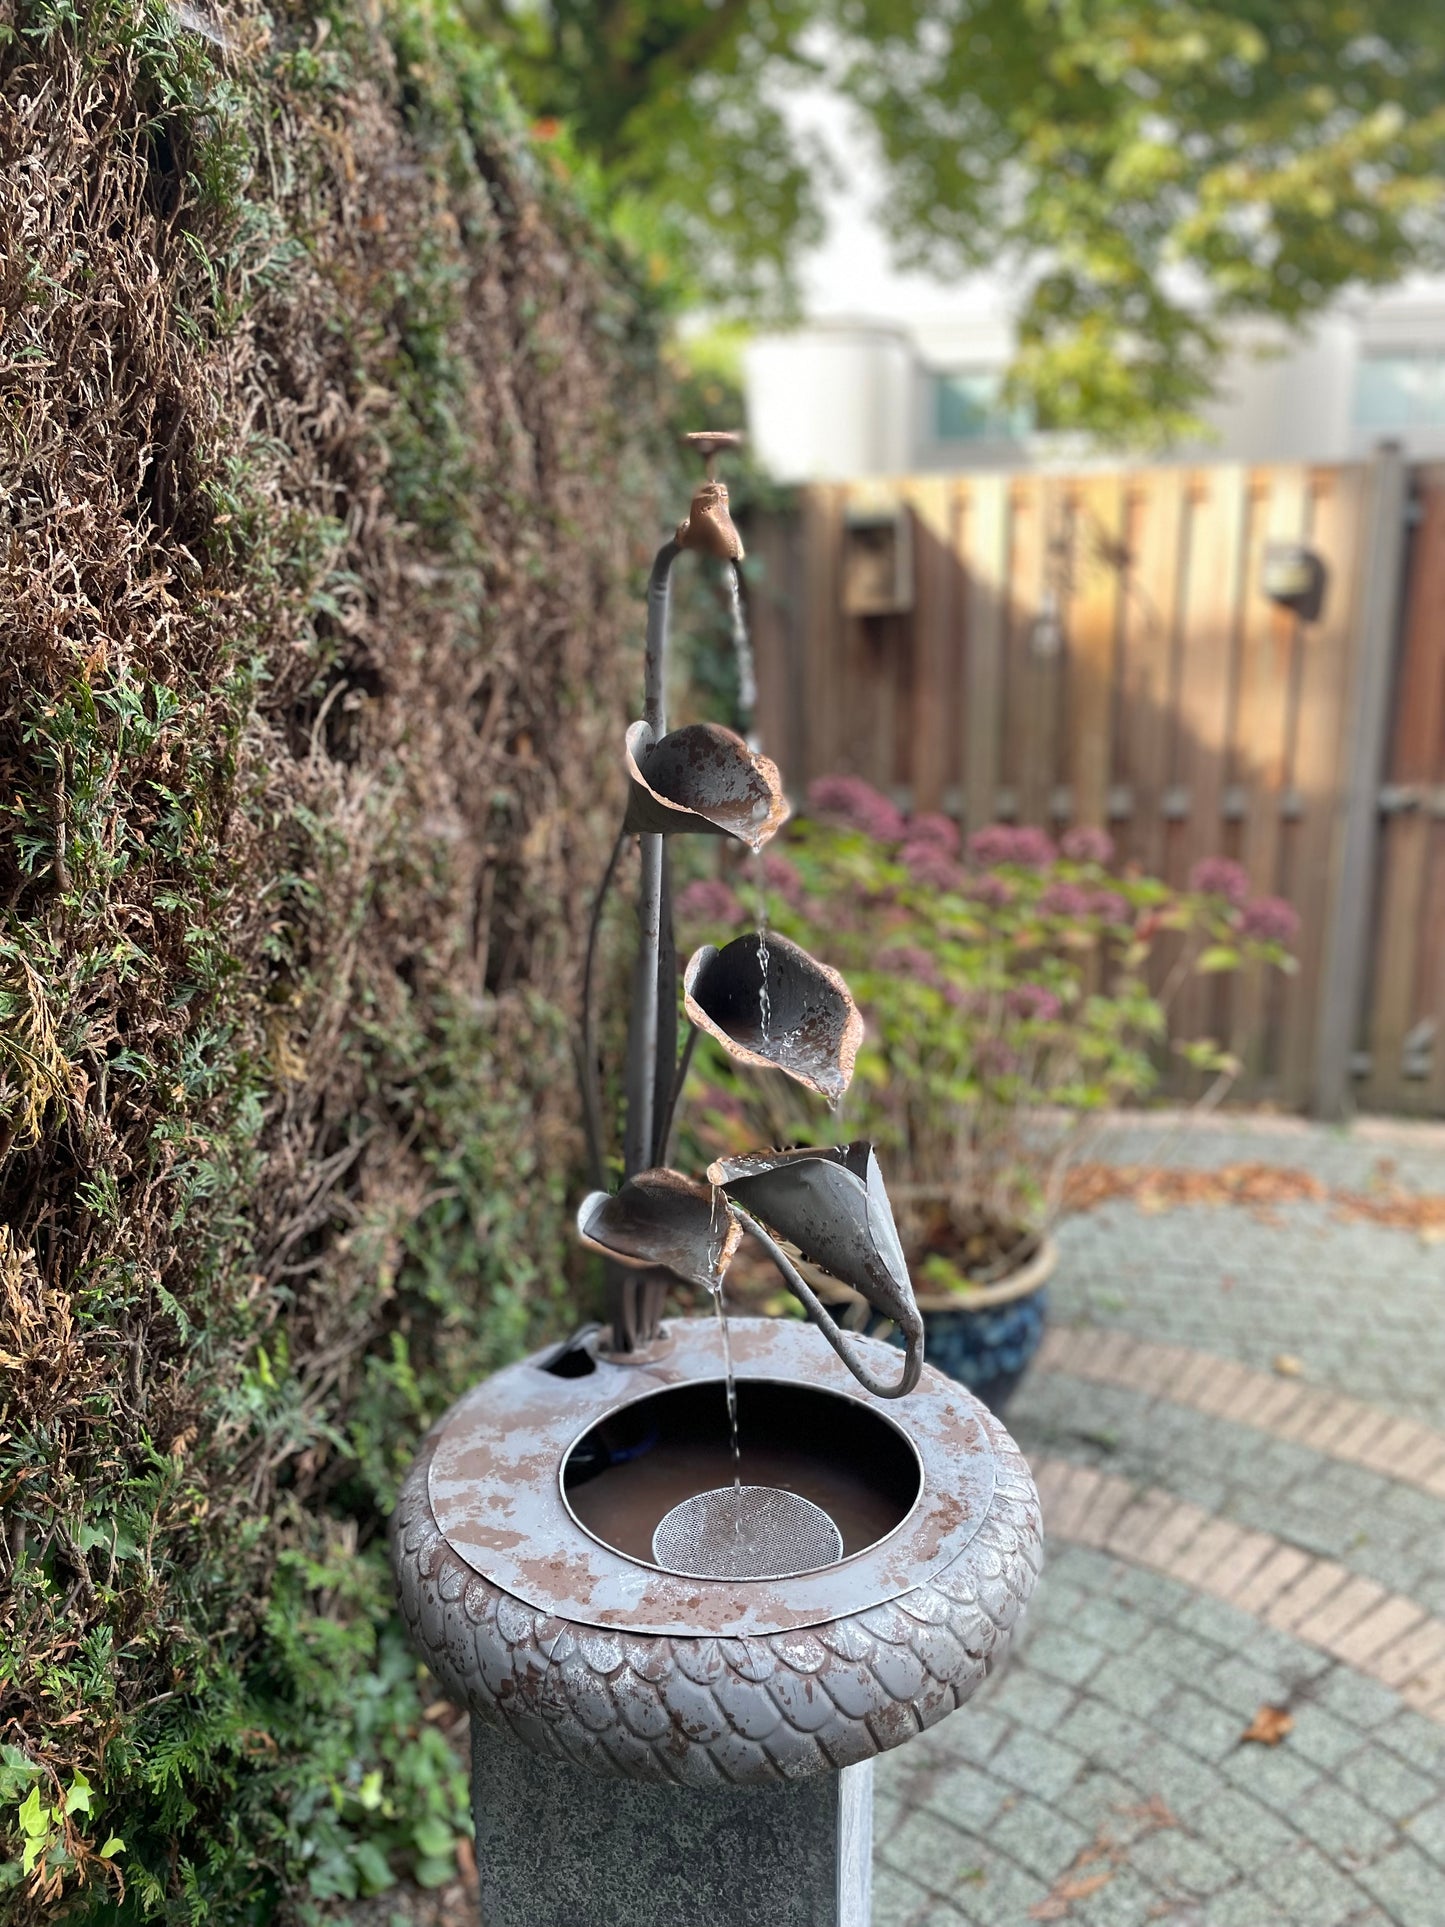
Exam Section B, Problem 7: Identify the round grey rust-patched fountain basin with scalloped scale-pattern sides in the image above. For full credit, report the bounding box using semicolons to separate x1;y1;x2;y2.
393;1318;1042;1786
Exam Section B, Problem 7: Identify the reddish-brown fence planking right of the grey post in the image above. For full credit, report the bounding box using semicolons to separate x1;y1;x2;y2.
1364;470;1445;1108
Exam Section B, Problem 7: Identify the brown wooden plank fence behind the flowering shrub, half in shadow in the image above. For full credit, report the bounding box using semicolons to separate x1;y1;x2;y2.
749;451;1445;1116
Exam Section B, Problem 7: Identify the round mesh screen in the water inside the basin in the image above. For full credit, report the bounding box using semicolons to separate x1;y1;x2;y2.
653;1486;842;1578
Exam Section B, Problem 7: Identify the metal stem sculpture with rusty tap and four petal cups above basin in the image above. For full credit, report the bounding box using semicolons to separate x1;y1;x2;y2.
578;432;923;1397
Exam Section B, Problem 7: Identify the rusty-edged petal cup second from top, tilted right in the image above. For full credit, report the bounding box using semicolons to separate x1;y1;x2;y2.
682;931;863;1098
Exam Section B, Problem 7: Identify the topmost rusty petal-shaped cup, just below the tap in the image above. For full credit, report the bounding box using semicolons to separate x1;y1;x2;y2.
624;723;790;850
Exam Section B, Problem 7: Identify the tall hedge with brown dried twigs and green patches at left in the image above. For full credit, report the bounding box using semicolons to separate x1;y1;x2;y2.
0;0;674;1927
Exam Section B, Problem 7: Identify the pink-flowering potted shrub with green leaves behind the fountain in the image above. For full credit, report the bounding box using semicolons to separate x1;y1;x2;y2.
678;777;1299;1285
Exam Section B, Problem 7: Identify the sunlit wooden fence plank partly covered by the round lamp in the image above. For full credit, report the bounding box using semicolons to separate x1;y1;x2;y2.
1229;468;1308;1071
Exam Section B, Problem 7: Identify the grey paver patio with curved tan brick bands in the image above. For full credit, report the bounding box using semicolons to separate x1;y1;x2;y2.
875;1122;1445;1927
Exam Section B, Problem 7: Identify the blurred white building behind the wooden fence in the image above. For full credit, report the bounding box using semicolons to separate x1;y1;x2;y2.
744;292;1445;482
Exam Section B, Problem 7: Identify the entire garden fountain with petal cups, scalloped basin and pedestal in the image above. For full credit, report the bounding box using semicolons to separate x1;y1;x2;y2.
393;436;1040;1927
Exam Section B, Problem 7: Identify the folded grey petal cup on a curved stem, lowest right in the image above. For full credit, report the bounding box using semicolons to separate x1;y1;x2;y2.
707;1141;921;1332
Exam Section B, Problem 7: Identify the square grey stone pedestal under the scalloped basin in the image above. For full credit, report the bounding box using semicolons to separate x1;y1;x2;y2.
472;1719;873;1927
